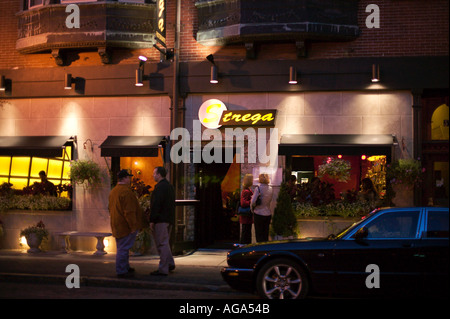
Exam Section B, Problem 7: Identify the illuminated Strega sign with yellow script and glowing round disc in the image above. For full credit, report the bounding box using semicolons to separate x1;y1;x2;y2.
198;99;277;129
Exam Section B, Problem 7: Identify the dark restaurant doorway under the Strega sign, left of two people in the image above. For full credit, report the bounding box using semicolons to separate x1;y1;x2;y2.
195;154;240;248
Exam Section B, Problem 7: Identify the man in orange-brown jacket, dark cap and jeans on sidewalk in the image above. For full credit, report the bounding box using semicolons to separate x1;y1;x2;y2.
108;169;144;278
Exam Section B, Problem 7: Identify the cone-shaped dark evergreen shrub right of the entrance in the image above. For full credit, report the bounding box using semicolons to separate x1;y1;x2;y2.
272;183;297;240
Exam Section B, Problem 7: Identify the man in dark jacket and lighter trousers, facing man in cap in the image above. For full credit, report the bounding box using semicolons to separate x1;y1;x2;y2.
150;166;175;276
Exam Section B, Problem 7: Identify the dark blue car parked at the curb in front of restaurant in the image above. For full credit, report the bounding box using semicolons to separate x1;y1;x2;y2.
222;207;449;299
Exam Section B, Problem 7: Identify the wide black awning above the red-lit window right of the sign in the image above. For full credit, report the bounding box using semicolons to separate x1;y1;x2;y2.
278;134;396;157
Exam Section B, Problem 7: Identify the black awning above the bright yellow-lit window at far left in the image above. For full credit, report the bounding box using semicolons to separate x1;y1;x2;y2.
0;136;71;157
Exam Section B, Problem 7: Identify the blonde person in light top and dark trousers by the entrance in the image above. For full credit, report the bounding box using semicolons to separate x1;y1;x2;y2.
251;173;273;243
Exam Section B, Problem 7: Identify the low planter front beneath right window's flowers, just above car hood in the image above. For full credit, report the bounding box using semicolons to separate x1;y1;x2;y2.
297;217;360;238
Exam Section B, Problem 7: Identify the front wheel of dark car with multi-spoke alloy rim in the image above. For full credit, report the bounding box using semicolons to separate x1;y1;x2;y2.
256;259;309;299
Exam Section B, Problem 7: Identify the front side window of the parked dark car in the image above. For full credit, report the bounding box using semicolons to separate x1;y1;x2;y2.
366;211;419;239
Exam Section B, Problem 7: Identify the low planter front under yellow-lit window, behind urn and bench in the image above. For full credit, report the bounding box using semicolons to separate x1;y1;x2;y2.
0;210;76;250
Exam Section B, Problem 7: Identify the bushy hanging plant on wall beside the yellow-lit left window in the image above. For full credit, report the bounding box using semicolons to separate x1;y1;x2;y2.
69;160;102;188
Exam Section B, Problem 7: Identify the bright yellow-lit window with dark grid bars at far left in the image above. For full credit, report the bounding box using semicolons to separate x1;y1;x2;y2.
0;146;72;197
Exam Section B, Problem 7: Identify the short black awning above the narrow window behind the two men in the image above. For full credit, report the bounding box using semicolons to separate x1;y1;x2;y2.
100;136;166;157
